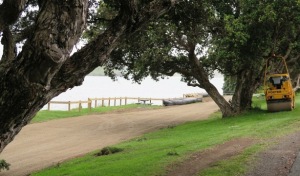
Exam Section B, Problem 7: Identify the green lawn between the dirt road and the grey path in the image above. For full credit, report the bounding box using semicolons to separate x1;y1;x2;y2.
33;97;300;176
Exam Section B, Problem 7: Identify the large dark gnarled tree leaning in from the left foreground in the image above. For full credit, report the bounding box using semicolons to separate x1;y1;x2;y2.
0;0;176;152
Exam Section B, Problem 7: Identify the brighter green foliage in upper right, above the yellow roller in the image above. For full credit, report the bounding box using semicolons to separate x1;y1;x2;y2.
211;0;300;74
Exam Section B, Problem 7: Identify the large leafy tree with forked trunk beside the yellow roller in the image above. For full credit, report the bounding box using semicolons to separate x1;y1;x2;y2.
95;0;300;117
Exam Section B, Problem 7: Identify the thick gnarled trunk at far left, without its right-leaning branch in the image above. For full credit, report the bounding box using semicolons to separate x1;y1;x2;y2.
0;0;87;152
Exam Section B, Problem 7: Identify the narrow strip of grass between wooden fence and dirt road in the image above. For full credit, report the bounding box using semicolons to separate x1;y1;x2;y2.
31;104;159;123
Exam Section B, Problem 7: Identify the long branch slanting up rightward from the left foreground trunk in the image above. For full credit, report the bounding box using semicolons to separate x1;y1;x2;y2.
53;0;176;91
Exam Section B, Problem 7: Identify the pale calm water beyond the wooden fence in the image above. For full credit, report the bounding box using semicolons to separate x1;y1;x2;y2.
43;76;224;110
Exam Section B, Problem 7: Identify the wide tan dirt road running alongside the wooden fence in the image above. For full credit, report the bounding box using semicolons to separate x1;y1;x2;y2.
0;101;218;176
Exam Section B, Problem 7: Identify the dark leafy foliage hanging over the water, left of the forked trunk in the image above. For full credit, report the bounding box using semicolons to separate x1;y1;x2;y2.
90;1;217;82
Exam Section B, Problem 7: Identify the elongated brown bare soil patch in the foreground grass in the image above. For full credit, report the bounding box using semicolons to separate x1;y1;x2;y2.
168;138;254;176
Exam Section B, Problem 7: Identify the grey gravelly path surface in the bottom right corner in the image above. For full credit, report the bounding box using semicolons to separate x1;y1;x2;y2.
246;131;300;176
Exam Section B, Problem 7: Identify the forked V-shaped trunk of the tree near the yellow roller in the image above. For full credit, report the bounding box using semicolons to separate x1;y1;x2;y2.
188;44;264;118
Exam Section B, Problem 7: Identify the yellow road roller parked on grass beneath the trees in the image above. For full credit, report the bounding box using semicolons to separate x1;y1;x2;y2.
264;56;295;112
